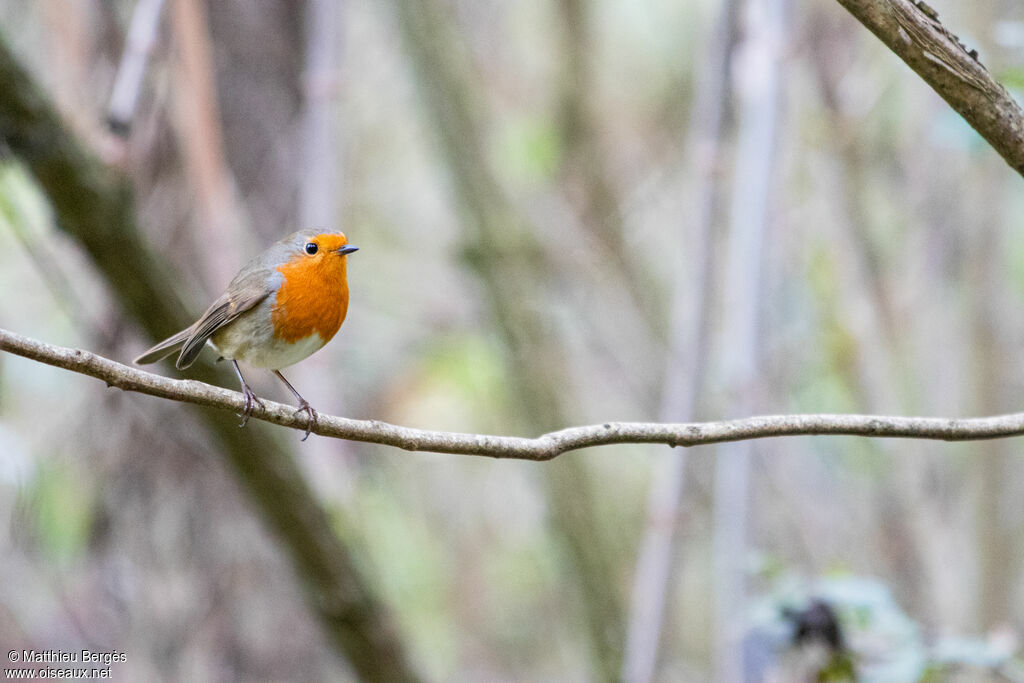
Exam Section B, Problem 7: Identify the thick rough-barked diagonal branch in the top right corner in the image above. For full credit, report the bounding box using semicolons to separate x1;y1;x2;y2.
839;0;1024;175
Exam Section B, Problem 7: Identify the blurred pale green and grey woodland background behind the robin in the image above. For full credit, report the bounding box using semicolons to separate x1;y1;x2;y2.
0;0;1024;680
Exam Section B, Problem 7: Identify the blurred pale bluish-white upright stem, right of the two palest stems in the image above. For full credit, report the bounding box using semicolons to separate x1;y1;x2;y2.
712;0;785;681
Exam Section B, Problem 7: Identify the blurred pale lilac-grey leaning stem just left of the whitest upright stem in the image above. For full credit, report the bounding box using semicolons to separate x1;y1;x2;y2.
622;0;738;683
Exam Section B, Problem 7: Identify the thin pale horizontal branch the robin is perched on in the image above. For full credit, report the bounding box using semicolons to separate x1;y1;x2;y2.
6;329;1024;461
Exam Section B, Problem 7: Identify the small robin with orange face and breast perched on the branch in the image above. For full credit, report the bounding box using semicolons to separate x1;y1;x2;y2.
135;231;358;440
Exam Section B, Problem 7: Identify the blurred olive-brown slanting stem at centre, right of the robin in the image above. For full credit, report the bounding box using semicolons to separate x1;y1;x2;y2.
394;0;623;681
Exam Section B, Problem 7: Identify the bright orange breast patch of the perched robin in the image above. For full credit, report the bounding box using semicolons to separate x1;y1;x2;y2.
271;253;348;344
